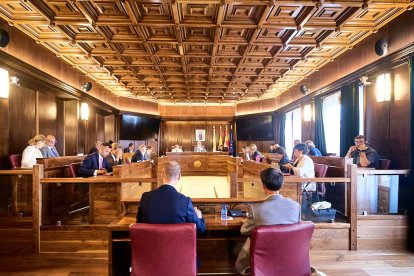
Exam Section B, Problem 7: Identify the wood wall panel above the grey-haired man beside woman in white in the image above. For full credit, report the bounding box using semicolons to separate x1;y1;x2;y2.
38;93;60;142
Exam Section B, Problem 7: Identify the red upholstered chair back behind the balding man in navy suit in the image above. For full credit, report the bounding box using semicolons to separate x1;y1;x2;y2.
129;223;197;276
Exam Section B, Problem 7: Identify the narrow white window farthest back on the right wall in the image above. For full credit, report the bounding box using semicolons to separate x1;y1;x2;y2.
285;107;302;157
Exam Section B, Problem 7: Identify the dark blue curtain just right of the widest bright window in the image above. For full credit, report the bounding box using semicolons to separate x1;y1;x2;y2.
340;82;359;156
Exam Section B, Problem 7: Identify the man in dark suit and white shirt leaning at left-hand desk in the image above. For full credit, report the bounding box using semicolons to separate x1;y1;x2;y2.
79;143;112;177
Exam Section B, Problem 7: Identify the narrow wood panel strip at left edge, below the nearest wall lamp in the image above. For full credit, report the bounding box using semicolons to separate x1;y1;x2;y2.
0;98;10;169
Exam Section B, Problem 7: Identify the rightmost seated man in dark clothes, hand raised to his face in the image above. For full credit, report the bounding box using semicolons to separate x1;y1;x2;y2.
345;135;378;168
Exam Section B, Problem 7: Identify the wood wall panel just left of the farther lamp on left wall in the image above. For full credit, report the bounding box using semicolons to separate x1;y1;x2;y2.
64;100;78;156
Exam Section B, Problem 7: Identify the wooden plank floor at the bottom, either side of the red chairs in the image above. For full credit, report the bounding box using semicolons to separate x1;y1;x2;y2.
0;250;414;276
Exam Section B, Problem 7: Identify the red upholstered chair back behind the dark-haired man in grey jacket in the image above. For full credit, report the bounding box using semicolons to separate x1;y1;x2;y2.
250;221;315;276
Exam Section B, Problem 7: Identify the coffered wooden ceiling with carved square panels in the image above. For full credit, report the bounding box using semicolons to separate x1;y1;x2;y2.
0;0;414;103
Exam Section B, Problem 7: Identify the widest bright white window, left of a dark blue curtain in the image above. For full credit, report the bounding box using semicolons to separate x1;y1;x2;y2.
322;92;341;156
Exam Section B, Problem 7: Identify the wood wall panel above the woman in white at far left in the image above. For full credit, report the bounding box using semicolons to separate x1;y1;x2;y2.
9;86;36;154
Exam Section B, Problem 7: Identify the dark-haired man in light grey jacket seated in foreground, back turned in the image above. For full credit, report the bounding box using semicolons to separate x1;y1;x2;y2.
236;168;300;275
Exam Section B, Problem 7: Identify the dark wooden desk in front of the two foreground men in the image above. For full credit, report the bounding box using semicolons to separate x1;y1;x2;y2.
108;214;245;276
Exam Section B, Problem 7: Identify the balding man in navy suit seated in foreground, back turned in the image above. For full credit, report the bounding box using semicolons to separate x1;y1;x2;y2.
137;161;206;234
